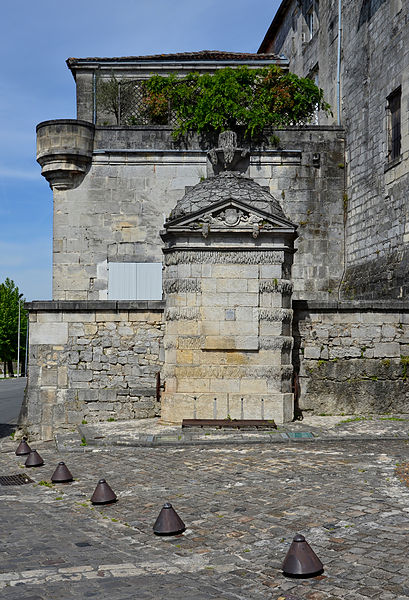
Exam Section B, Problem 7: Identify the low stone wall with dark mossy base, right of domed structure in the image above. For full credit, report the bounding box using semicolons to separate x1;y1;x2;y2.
293;301;409;414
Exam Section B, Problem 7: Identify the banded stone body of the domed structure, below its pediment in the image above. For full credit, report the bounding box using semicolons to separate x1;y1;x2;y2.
162;244;293;423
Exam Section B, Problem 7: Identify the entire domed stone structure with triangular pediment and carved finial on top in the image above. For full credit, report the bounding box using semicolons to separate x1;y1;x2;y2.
162;137;296;423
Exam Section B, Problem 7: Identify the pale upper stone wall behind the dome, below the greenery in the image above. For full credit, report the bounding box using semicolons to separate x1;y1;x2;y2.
39;122;345;300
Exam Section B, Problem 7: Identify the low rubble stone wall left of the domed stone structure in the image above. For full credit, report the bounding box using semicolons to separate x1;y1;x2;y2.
20;301;163;439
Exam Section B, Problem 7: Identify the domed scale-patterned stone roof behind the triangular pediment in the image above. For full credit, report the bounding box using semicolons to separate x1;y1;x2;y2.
170;171;286;220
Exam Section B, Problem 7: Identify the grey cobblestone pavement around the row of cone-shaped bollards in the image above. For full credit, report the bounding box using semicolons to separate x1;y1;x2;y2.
0;428;409;600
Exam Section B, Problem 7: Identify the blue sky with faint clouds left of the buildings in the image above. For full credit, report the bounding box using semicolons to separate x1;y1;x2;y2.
0;0;280;300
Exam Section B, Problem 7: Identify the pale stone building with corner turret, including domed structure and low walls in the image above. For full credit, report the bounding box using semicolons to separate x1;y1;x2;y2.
21;38;409;437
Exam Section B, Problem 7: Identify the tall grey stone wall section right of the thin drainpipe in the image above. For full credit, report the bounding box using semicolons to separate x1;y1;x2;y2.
342;0;409;300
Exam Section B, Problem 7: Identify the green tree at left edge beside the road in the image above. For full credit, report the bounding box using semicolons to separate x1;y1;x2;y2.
0;277;27;376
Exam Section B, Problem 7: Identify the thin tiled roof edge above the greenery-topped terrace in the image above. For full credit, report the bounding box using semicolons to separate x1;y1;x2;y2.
67;50;287;67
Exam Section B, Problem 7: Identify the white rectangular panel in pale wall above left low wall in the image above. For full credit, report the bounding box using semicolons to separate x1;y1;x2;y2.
108;262;162;300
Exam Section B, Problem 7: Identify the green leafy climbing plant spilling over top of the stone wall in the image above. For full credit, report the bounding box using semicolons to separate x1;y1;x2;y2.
145;66;330;137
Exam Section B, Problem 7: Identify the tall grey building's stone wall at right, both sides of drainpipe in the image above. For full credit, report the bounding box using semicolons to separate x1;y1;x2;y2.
262;0;409;300
